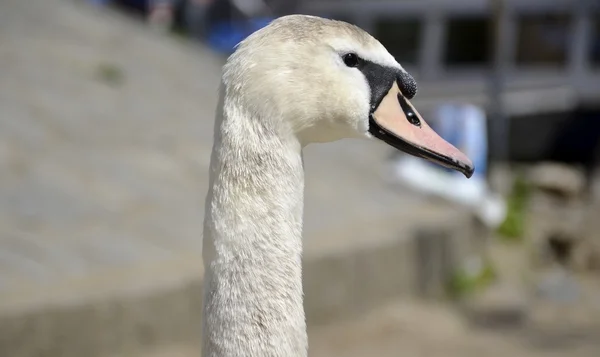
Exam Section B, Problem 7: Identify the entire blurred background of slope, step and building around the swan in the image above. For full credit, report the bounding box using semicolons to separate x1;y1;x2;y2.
0;0;600;357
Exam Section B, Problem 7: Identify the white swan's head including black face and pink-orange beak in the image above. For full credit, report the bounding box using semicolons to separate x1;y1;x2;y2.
223;15;474;177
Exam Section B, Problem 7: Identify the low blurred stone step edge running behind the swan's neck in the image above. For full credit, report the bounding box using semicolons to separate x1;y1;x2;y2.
0;203;472;357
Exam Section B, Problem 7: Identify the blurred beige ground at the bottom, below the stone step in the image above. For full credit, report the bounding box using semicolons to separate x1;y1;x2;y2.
116;301;600;357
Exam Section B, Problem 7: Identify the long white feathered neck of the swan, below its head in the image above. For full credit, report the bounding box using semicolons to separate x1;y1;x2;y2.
202;92;307;357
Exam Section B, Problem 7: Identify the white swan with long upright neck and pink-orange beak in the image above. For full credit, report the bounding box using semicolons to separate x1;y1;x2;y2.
202;15;474;357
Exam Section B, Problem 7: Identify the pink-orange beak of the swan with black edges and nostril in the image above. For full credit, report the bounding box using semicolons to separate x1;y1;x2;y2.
369;82;475;178
